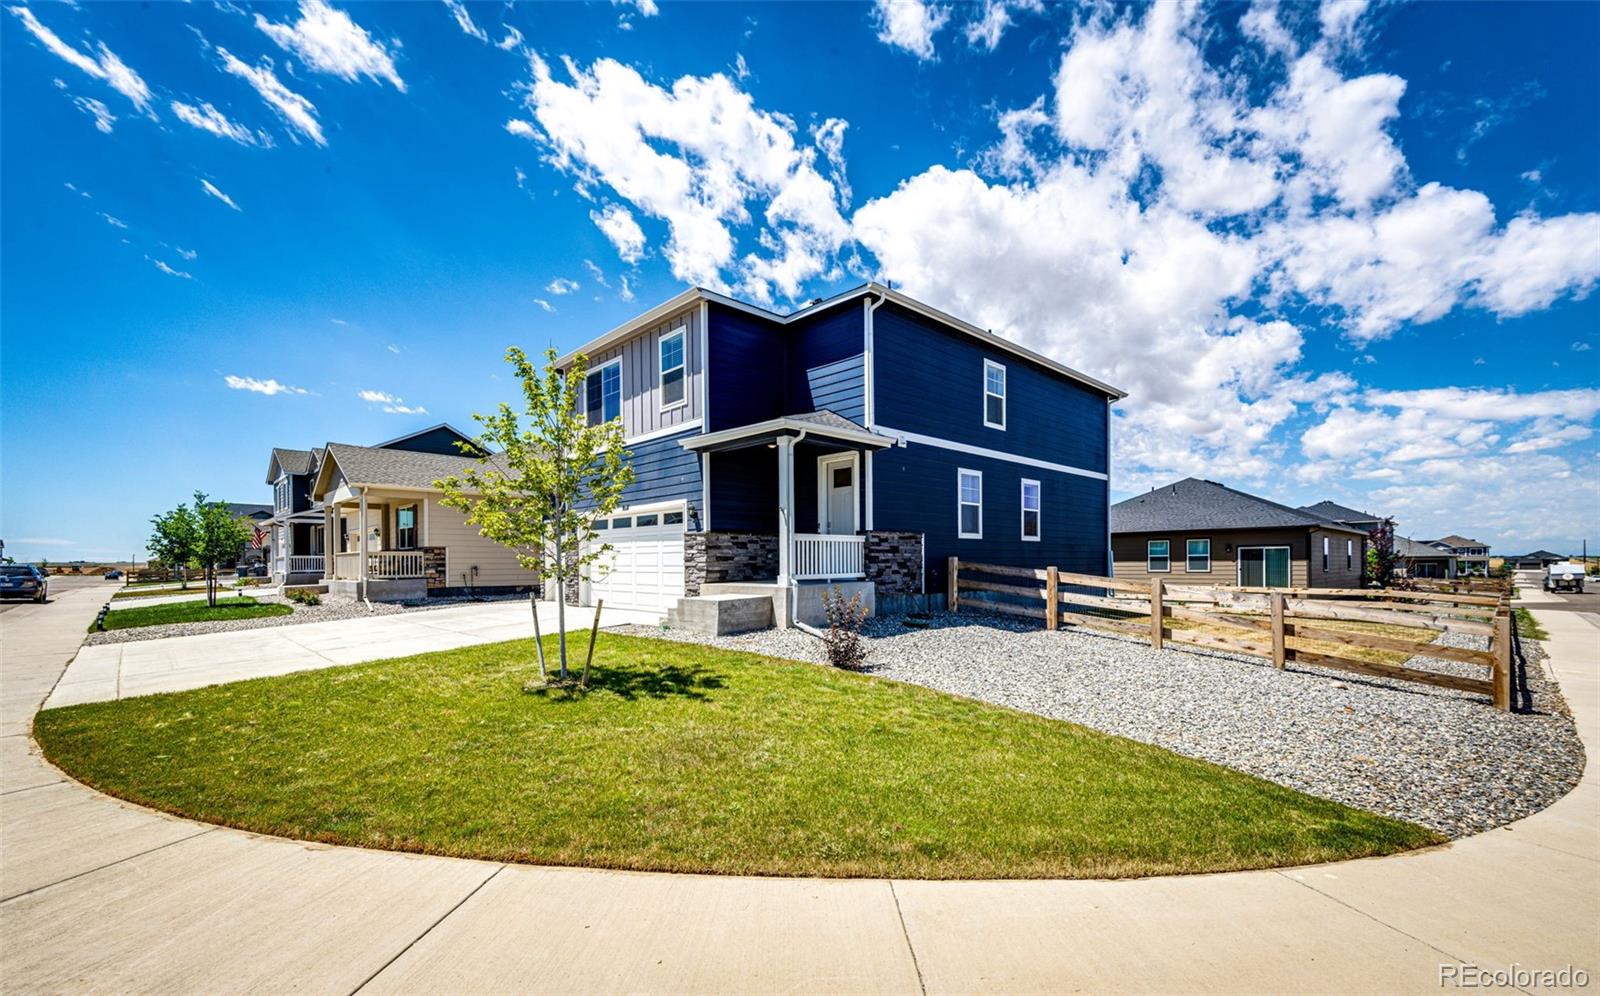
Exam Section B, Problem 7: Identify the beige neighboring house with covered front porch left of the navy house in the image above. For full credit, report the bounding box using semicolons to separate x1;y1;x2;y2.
309;429;539;600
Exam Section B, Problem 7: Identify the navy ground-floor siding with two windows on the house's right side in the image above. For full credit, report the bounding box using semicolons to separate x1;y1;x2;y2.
872;444;1107;592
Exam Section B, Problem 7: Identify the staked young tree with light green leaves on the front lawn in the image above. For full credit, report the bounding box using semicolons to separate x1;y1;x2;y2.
434;346;634;682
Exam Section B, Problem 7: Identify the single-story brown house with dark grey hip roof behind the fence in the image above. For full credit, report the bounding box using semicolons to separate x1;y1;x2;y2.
1110;477;1366;588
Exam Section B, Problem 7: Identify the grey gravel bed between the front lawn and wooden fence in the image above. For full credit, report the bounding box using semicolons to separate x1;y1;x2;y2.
619;612;1584;837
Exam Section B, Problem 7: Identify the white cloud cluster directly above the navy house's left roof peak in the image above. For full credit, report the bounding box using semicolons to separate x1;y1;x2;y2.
526;58;850;301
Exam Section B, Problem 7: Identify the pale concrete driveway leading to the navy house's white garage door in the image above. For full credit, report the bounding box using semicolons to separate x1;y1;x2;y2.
45;599;661;709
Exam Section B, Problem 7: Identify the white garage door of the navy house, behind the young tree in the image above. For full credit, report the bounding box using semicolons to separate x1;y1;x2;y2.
589;508;683;613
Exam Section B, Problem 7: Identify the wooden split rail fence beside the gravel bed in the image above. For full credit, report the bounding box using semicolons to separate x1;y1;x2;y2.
947;557;1512;709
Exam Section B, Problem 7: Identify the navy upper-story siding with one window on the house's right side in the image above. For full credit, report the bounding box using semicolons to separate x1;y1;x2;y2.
872;304;1110;470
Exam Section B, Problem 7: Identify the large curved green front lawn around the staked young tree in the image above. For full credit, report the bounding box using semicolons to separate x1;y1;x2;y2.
34;634;1440;878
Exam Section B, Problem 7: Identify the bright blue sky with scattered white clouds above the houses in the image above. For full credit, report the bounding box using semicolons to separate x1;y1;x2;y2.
0;0;1600;560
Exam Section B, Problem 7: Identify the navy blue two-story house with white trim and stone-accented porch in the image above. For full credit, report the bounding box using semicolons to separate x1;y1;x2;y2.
552;283;1125;623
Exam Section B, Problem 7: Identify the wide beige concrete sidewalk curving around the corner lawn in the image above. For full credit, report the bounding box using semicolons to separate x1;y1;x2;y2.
0;582;1600;993
